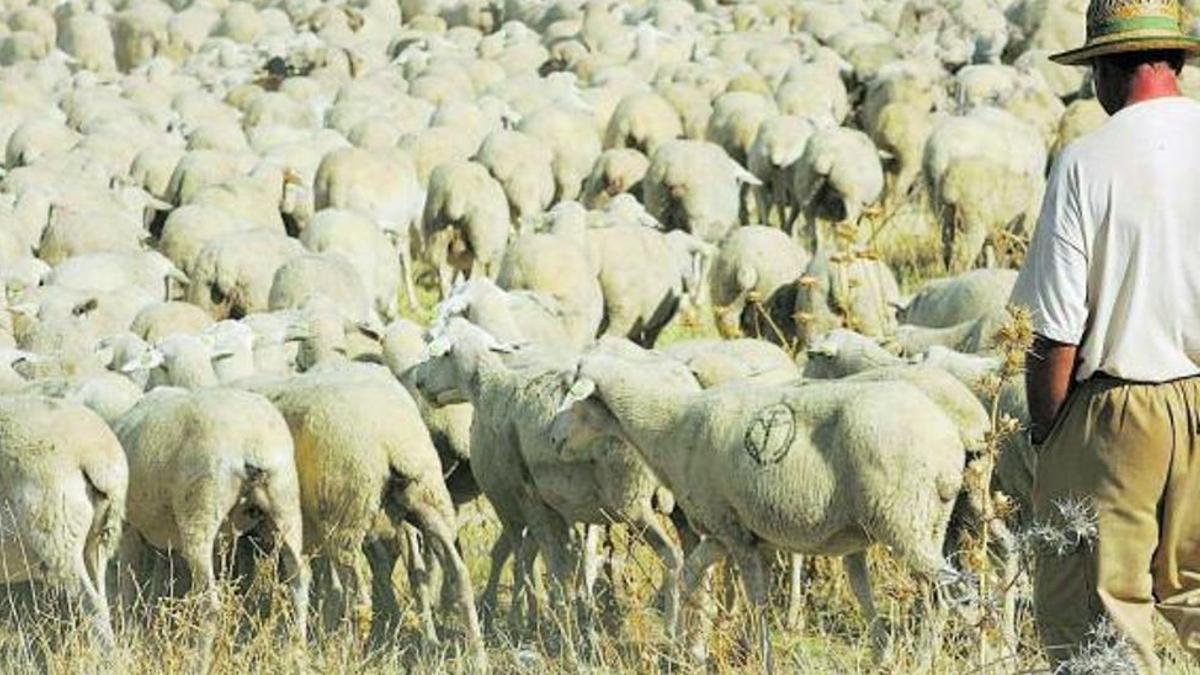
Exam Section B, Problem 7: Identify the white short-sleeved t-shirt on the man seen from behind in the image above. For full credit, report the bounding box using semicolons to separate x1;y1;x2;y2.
1013;97;1200;382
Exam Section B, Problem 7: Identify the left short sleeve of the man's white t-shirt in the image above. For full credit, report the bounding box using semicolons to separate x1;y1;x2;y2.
1012;151;1088;345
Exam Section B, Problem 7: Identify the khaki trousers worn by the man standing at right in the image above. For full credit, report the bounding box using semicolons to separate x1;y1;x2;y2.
1033;378;1200;674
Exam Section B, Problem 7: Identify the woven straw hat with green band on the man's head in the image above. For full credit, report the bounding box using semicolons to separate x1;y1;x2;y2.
1050;0;1200;66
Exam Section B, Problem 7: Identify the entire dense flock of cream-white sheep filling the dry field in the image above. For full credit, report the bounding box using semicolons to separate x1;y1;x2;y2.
0;0;1198;663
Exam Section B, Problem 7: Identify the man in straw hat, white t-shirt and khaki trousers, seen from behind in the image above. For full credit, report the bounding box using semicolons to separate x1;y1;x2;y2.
1013;0;1200;674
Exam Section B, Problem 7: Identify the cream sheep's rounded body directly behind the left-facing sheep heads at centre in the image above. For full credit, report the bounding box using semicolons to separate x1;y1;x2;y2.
496;233;605;348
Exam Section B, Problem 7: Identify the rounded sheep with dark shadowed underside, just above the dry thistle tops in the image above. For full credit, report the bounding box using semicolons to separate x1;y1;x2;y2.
788;127;883;250
